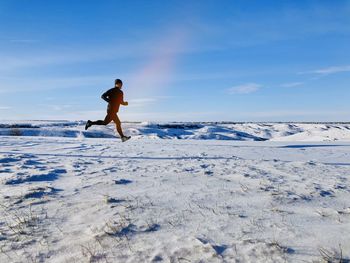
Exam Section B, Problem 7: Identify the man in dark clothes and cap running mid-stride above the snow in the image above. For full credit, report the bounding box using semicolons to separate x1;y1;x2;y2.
85;79;131;142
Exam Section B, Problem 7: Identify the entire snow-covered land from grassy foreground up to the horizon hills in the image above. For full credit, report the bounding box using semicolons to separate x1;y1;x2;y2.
0;122;350;262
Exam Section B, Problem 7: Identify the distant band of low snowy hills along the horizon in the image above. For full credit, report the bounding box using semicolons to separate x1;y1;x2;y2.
0;121;350;141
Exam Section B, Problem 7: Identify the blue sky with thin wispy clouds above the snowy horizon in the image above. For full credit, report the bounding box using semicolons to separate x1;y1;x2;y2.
0;0;350;121
